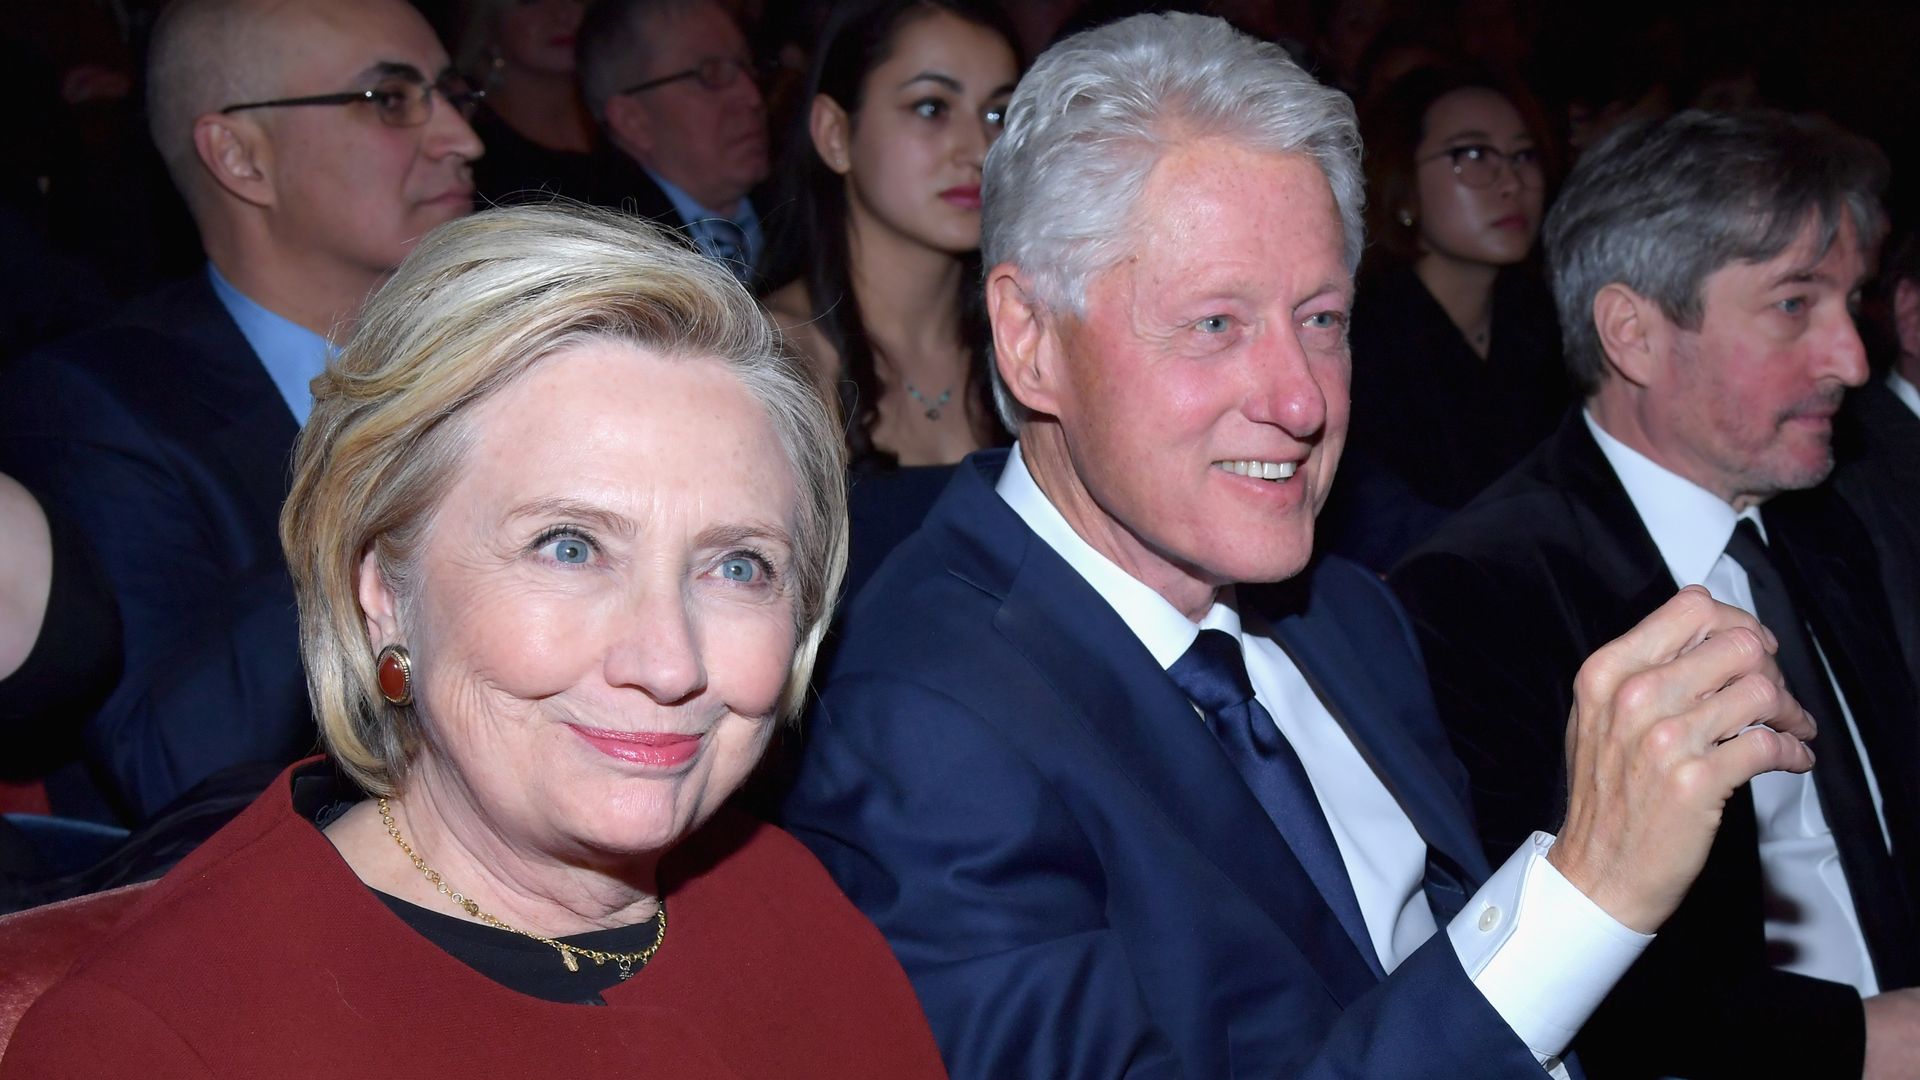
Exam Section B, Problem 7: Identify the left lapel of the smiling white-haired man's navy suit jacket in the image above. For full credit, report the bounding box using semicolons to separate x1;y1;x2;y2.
929;455;1377;1005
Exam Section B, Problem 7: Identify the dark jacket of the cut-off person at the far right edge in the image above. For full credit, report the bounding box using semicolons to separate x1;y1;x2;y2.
1834;379;1920;686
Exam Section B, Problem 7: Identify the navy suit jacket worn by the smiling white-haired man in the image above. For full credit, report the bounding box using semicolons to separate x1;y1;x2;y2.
785;452;1542;1080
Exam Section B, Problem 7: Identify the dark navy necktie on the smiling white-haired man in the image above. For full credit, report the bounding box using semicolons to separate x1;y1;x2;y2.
1167;630;1382;972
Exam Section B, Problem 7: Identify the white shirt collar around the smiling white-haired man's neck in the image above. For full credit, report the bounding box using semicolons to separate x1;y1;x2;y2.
993;442;1240;669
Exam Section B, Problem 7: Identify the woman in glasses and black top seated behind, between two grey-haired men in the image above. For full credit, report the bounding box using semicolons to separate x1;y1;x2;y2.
1350;69;1571;530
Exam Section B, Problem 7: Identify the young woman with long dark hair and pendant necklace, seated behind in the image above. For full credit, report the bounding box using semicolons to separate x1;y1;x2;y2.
766;0;1020;467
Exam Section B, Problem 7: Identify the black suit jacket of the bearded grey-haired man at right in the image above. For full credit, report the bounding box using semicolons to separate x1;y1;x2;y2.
1392;411;1920;1080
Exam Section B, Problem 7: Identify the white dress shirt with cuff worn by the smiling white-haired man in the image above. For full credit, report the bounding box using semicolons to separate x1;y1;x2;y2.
996;444;1653;1076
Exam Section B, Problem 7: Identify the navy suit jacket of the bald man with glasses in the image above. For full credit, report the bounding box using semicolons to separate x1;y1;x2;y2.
0;275;313;819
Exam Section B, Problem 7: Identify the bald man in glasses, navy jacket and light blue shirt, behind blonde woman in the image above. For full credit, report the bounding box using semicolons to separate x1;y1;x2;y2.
0;0;482;822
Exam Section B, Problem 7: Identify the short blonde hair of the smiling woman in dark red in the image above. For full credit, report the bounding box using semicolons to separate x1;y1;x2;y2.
280;206;847;794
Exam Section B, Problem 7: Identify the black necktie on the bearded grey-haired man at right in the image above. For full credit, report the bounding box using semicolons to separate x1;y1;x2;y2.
1726;519;1916;988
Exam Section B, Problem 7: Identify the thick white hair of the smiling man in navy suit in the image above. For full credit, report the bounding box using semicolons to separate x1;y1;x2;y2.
981;13;1367;432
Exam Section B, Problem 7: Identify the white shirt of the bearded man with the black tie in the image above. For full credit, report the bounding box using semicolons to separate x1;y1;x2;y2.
1586;413;1891;995
